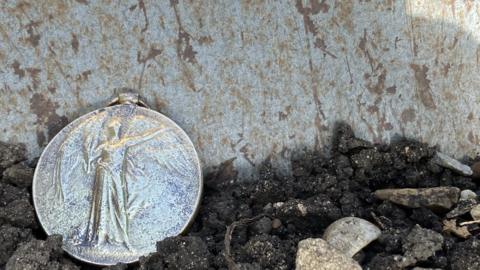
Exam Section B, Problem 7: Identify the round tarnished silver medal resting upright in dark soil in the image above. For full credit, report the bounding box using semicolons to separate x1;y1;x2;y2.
32;93;203;265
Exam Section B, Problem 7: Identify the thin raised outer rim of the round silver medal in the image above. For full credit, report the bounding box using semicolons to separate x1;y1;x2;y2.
32;104;204;266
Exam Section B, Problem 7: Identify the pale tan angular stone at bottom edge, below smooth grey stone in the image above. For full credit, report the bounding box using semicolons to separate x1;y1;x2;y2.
295;238;362;270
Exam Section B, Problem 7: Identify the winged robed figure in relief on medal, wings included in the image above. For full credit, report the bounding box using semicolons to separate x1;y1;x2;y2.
53;106;194;249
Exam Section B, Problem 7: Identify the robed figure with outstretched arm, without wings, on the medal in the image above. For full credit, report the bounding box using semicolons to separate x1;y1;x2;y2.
85;117;161;248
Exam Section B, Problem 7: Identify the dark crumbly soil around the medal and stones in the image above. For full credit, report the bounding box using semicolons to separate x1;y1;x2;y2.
0;124;480;270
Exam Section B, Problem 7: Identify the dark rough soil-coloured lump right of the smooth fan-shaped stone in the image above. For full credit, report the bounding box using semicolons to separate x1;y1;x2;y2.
402;225;443;262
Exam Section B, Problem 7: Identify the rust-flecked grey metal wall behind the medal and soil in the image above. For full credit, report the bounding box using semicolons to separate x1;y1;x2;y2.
0;0;480;179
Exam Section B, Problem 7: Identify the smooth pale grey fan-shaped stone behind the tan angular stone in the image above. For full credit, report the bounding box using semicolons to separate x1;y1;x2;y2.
323;217;382;257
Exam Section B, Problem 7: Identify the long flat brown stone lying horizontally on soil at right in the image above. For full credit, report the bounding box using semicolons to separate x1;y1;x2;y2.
374;187;460;210
